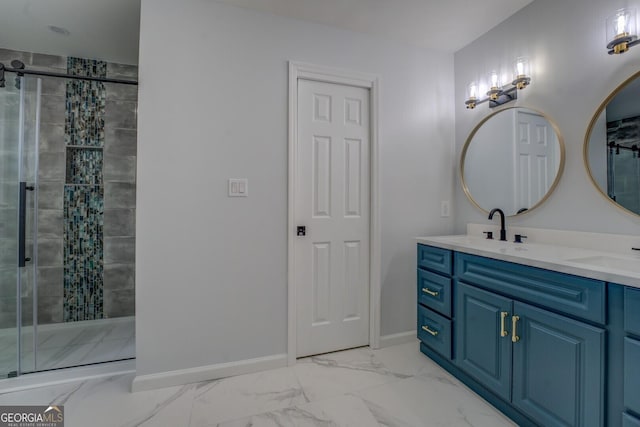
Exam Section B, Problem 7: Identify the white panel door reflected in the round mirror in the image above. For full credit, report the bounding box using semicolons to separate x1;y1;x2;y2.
514;111;558;210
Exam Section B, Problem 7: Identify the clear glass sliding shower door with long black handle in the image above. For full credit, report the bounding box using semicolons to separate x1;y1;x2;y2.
0;74;37;378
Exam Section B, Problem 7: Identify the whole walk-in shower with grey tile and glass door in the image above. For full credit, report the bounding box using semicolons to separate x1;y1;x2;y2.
0;49;137;378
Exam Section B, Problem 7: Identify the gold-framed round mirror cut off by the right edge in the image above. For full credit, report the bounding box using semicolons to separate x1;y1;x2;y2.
584;72;640;215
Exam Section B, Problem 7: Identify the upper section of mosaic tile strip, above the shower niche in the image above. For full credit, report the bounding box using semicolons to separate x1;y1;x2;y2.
65;57;107;147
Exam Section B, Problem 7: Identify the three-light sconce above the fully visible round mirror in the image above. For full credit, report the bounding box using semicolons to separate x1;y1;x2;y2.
464;57;531;110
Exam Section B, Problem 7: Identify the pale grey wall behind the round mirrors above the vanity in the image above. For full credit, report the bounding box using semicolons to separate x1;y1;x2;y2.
454;0;640;234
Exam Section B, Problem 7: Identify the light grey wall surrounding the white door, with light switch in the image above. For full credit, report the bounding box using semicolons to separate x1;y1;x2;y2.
136;0;454;382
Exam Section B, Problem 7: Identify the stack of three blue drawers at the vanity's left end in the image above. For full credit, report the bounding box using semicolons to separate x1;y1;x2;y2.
417;245;453;359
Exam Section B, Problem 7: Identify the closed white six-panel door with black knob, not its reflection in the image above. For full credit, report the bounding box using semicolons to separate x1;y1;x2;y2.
294;79;370;357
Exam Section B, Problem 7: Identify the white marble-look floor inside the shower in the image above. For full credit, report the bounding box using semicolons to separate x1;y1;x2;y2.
0;316;135;378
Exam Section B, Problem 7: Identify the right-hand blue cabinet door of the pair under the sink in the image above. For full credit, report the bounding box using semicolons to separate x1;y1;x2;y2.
512;302;605;426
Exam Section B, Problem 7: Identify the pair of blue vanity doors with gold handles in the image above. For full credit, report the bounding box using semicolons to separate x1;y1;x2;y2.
455;283;605;426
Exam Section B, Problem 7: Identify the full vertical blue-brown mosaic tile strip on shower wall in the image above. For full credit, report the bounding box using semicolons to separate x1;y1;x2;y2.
63;57;107;322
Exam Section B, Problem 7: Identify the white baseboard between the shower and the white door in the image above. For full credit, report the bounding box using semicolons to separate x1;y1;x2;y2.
131;354;287;392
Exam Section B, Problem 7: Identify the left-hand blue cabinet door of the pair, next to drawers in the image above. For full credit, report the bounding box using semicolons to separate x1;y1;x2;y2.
454;283;513;401
